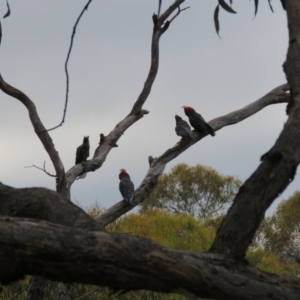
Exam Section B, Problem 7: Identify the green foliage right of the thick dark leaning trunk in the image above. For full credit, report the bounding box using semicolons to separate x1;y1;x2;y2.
254;191;300;278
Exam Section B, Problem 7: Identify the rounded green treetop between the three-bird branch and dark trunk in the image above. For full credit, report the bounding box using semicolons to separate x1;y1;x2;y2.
140;164;241;220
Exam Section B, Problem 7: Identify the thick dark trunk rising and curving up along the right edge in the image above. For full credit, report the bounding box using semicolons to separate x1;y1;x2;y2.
212;0;300;259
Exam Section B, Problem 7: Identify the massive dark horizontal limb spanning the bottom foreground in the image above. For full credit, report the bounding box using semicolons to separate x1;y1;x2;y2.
0;217;300;300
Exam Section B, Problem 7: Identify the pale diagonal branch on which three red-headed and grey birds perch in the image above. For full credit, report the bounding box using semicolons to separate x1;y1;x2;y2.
96;84;290;226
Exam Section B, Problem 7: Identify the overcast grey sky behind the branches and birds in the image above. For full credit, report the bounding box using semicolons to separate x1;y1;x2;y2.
0;0;290;214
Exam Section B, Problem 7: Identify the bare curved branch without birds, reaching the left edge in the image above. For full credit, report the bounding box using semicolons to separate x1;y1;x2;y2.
0;75;69;199
